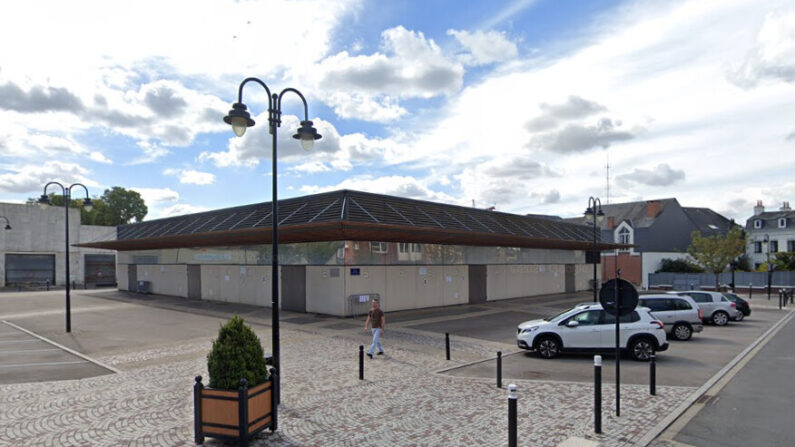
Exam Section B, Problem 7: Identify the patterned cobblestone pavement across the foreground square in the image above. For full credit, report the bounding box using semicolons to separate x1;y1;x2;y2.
0;324;693;446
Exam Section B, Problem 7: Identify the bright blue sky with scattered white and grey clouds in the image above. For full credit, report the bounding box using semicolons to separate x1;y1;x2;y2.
0;0;795;222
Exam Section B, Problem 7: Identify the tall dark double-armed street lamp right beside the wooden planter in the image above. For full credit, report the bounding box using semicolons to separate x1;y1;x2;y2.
224;78;320;431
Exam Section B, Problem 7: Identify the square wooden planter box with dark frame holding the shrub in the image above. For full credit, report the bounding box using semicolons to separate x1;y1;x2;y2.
193;374;276;446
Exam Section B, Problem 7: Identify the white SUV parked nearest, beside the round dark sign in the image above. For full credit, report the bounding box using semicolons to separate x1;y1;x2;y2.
516;304;668;361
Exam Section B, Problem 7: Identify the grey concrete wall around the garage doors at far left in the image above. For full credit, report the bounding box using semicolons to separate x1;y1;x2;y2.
0;203;116;286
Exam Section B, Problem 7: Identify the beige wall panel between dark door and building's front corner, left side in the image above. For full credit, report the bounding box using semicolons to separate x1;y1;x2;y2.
306;266;347;316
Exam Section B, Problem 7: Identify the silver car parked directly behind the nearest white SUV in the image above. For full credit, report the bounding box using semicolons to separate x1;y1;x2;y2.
638;294;704;341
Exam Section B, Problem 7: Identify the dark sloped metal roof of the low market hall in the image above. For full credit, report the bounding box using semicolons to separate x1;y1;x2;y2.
79;190;618;250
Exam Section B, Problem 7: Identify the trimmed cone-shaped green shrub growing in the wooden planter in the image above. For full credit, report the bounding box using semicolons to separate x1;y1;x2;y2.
207;315;268;390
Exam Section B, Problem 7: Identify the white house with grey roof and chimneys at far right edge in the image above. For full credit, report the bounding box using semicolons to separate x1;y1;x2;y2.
745;200;795;269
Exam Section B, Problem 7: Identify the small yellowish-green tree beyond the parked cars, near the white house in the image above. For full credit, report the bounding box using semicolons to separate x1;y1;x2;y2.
687;226;745;290
